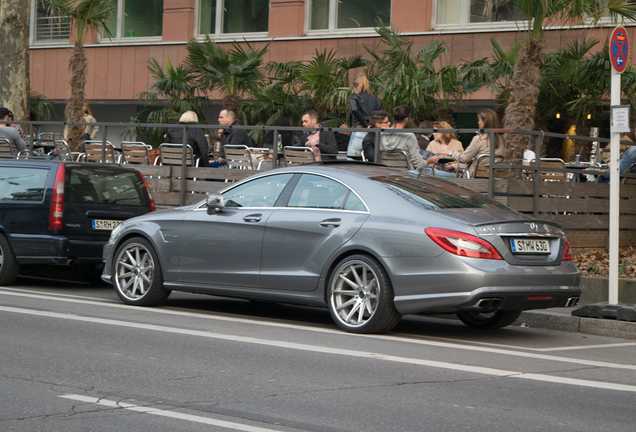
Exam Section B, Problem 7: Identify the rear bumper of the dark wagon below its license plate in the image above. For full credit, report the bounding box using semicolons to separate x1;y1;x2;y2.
9;234;106;265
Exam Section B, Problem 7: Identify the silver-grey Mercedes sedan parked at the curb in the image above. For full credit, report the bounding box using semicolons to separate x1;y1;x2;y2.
102;163;581;333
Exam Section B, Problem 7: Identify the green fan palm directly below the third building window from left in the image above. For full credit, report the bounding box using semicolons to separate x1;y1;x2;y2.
185;36;269;113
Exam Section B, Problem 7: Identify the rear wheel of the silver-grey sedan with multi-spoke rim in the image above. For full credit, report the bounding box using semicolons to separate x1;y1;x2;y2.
327;255;402;333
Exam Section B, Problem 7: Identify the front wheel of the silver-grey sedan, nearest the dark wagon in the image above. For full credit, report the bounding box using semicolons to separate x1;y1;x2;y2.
111;237;170;306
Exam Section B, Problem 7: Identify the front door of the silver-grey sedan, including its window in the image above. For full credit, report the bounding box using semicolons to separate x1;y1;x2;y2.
179;174;293;288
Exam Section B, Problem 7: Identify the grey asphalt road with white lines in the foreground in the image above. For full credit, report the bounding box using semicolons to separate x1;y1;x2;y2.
0;278;636;432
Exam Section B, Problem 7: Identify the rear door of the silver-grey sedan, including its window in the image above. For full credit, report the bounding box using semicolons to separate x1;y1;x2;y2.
261;174;369;292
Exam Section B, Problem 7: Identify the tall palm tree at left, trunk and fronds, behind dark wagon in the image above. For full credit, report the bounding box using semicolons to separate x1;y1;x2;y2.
50;0;114;151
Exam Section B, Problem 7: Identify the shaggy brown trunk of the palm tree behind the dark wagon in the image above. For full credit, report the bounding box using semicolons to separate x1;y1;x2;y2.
64;44;88;151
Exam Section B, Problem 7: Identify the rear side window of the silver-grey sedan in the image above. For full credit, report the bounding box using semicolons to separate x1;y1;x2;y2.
287;174;366;210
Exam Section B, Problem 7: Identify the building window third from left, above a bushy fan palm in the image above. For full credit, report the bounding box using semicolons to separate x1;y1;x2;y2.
199;0;269;35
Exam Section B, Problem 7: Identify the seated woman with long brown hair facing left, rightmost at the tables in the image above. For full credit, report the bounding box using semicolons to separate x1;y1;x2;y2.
448;108;504;178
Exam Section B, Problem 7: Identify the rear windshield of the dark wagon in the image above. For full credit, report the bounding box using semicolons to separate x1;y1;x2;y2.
64;165;150;207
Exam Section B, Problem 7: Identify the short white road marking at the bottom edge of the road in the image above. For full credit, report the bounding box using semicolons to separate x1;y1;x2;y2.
59;394;280;432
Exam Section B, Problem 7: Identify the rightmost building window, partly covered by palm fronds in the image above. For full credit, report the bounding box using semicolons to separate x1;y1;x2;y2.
437;0;524;27
